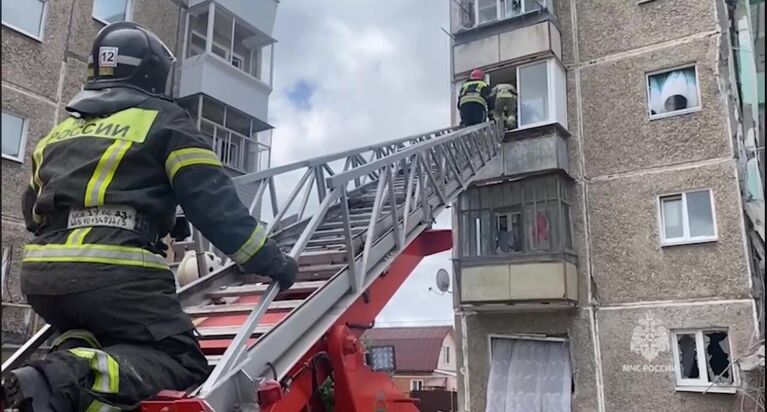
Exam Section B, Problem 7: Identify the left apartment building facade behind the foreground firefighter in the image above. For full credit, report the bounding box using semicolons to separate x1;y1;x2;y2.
2;0;278;352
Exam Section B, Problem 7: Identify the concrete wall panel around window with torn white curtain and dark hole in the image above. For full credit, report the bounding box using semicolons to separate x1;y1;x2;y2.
581;36;730;176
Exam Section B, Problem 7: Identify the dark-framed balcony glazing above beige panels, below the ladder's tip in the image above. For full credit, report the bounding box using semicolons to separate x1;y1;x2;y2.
459;176;572;256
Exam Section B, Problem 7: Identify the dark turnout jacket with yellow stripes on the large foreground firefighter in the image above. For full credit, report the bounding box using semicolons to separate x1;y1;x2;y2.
22;88;266;295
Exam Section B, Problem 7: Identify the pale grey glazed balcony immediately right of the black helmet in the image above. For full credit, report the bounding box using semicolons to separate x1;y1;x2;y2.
179;1;273;120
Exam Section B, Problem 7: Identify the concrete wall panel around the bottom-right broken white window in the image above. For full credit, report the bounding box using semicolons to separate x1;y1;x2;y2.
597;301;755;412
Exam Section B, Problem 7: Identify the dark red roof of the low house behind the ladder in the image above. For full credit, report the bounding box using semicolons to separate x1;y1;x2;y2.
363;326;453;372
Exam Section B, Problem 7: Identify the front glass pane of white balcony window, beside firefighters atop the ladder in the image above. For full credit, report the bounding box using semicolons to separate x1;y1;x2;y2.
518;62;549;126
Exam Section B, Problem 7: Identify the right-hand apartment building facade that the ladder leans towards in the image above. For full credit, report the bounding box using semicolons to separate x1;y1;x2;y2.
449;0;764;412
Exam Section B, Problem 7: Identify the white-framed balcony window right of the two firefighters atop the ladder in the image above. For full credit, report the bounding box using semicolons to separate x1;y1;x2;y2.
516;59;567;129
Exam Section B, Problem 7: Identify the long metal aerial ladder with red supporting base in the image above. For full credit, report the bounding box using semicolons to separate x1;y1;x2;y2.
2;122;502;412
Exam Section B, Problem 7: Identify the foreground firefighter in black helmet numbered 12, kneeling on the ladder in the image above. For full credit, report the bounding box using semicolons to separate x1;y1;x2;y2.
3;22;298;412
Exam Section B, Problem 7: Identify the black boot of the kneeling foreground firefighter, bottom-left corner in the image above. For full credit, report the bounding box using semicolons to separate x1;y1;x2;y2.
3;366;52;412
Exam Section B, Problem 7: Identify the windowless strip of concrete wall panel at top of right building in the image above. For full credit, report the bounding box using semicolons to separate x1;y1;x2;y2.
576;0;717;62
